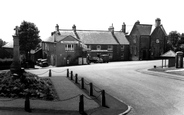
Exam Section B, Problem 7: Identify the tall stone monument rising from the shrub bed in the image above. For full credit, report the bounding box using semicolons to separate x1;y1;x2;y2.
10;26;21;73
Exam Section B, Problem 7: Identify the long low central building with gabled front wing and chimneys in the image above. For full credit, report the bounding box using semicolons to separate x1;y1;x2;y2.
42;25;129;66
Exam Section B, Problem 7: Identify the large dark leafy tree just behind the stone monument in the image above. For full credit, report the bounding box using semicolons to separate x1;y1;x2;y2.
19;21;41;60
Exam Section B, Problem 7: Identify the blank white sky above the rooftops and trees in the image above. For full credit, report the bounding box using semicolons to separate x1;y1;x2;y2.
0;0;184;42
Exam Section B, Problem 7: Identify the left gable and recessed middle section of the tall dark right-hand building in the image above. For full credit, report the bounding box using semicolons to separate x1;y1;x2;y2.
128;21;152;60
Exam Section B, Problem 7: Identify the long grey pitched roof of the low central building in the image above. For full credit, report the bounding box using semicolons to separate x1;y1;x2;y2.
60;30;129;44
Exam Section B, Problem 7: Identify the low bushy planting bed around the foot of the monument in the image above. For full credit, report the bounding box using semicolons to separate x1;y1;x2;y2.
0;71;58;100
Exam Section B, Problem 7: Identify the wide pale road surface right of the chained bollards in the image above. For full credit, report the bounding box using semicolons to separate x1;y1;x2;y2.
62;60;184;115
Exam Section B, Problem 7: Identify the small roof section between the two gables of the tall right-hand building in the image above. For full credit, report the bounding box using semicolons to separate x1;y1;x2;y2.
136;24;152;35
